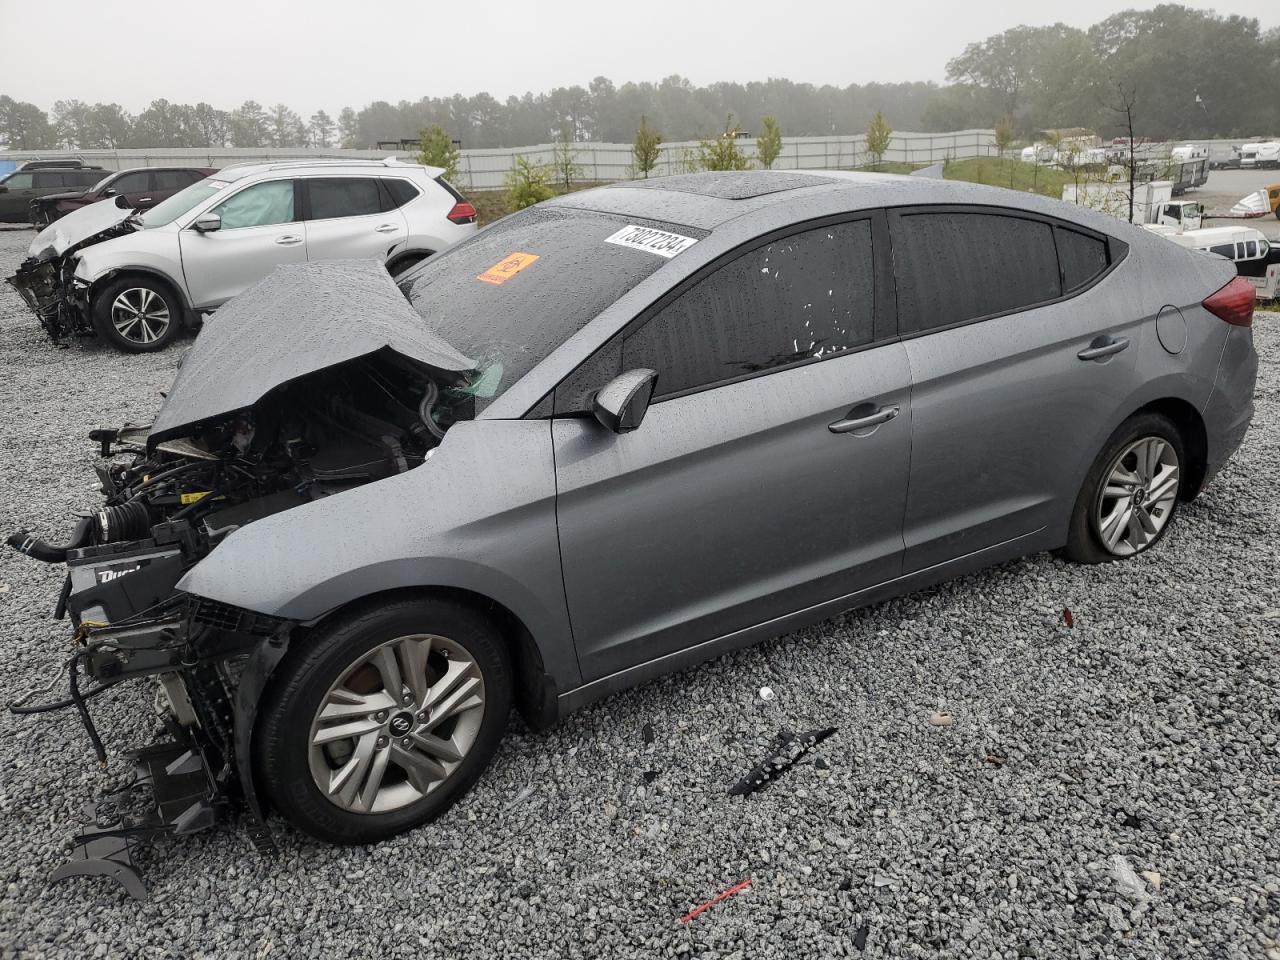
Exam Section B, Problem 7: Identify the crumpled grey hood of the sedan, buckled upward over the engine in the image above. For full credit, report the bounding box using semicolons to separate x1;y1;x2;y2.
146;257;476;449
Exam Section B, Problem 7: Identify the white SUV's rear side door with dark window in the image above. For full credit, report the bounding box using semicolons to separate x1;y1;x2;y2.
302;177;408;261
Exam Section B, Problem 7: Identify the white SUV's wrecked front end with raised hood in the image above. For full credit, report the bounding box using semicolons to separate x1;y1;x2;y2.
8;197;137;344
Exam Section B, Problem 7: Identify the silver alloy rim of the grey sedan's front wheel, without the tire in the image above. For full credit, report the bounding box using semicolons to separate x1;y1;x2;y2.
308;634;485;813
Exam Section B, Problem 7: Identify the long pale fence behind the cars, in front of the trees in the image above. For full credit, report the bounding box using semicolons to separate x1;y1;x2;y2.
0;131;996;189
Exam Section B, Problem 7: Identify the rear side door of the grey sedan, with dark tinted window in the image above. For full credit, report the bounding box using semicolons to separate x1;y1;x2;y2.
890;207;1143;572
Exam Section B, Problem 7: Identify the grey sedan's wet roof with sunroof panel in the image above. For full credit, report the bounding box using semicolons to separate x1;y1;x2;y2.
541;170;1146;236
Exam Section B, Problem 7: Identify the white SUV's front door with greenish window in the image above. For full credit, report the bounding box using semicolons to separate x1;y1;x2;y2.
179;179;307;308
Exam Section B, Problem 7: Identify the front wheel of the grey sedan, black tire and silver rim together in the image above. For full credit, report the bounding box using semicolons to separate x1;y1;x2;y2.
253;599;512;844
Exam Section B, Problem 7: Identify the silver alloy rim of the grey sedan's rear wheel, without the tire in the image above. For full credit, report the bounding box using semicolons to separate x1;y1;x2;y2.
1094;436;1180;557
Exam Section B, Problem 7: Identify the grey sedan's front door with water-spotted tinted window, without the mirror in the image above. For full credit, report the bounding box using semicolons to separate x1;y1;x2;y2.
553;216;910;680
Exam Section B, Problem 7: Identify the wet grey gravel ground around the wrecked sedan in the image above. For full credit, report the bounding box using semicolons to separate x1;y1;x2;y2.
0;230;1280;960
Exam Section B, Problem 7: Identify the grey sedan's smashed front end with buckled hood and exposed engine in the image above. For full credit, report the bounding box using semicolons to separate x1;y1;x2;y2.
9;261;474;896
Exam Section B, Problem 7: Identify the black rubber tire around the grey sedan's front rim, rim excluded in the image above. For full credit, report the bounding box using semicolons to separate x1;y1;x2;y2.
253;598;512;844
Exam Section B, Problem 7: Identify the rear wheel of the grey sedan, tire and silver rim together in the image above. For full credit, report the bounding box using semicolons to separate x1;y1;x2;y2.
1062;413;1187;563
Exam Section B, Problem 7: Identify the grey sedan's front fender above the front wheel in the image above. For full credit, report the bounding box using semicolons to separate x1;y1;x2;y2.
178;420;580;689
